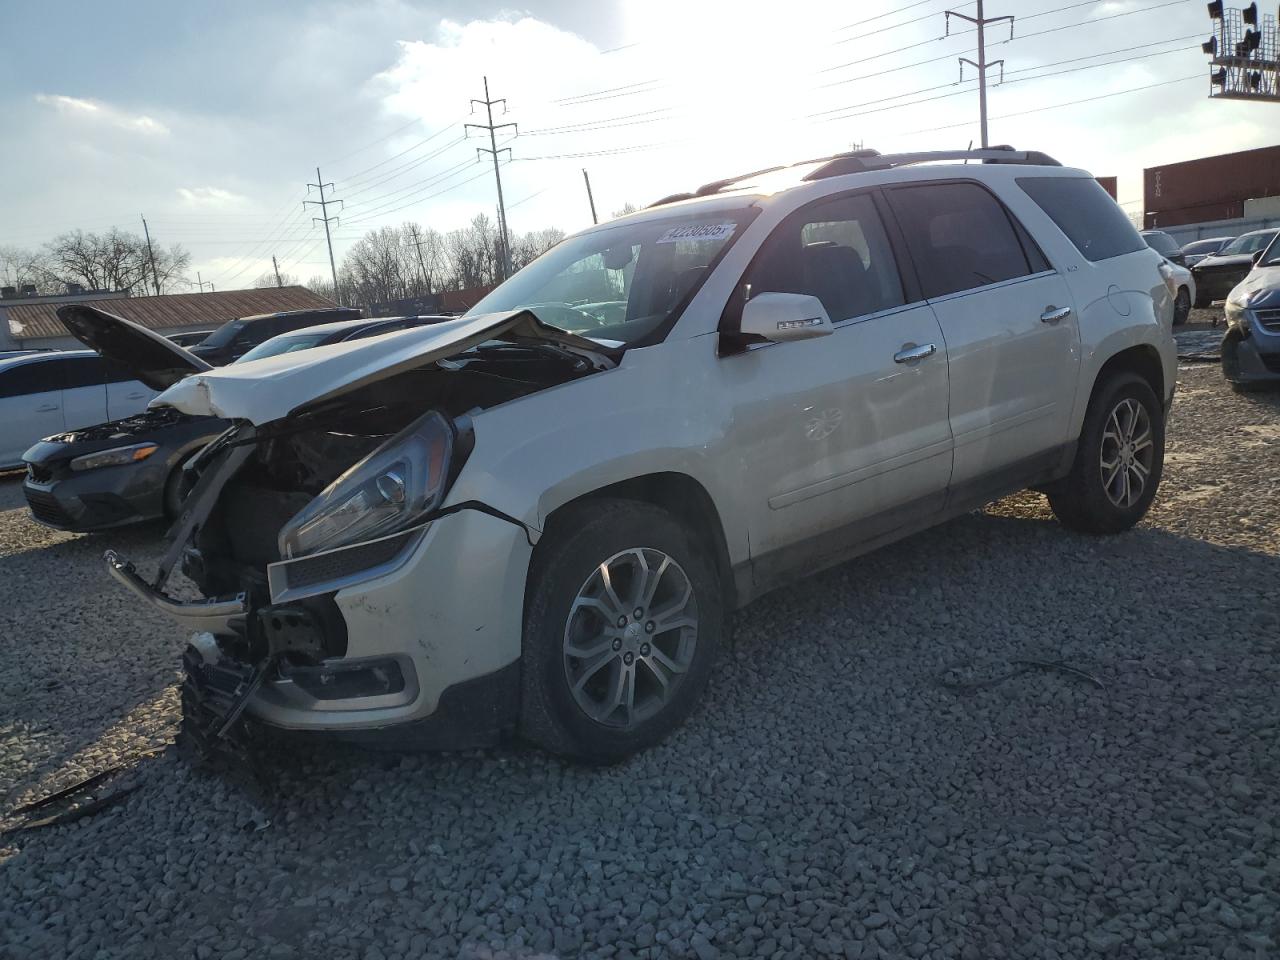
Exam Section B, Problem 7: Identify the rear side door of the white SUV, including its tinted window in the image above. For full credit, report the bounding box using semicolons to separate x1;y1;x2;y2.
887;180;1080;489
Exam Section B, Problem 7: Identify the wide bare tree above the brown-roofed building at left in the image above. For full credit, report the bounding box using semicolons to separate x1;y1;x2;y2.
45;228;191;296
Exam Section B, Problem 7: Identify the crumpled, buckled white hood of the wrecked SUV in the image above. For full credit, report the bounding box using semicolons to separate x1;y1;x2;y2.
151;310;616;425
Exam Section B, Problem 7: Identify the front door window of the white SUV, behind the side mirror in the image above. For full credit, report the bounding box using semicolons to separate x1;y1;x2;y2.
748;193;905;323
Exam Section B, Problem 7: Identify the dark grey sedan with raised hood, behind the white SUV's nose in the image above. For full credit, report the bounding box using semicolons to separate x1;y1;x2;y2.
23;307;451;532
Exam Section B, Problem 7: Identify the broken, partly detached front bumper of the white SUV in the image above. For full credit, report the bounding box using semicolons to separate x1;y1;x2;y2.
108;509;532;746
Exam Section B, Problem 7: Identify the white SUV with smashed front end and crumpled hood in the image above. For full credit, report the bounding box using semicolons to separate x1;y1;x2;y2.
82;148;1175;760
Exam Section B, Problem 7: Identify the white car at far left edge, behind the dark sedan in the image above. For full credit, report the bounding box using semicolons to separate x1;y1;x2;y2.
0;349;156;470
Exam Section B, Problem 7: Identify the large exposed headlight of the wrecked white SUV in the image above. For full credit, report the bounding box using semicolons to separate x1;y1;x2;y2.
279;413;453;559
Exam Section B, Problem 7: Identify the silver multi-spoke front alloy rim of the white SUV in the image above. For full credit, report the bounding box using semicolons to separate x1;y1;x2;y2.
563;547;698;730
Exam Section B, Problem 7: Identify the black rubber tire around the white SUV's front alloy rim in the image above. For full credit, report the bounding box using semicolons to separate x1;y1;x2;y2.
521;500;724;763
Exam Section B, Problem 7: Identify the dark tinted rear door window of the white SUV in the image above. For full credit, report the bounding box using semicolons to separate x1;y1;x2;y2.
888;183;1042;297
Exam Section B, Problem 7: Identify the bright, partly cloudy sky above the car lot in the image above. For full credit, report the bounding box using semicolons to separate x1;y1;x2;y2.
0;0;1280;289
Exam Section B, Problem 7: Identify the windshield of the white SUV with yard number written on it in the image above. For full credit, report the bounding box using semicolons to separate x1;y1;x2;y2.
467;207;759;344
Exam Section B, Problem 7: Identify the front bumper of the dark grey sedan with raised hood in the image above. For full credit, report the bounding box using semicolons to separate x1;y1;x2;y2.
22;462;168;532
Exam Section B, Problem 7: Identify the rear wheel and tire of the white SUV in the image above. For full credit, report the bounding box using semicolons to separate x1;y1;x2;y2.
1048;374;1165;534
